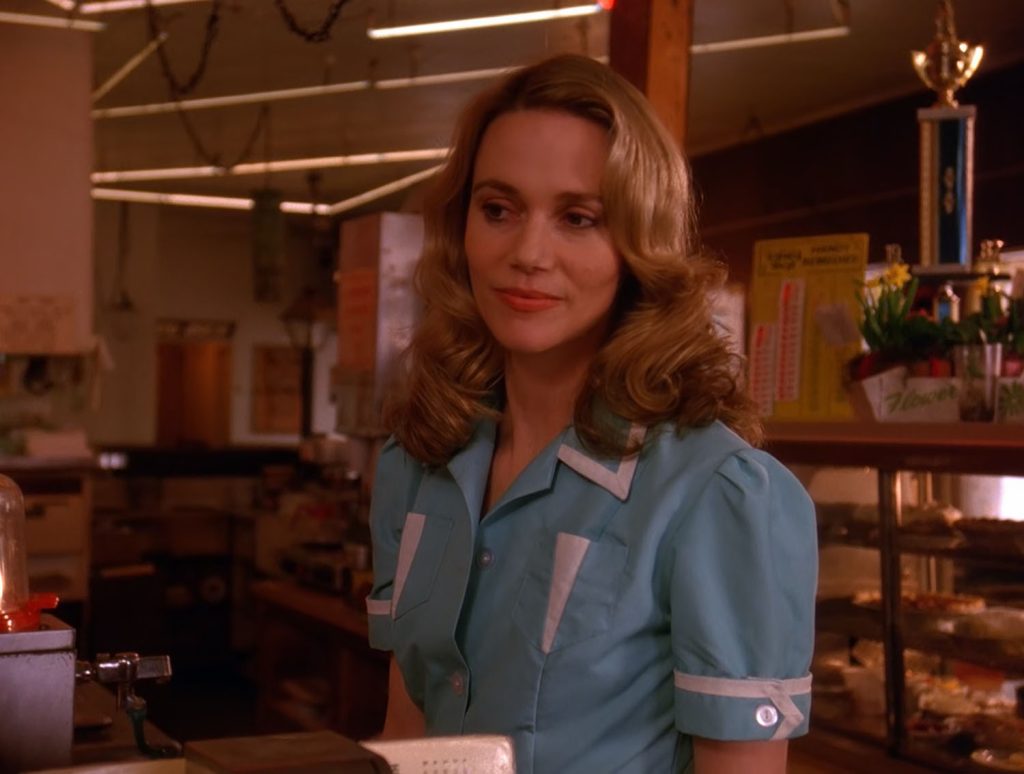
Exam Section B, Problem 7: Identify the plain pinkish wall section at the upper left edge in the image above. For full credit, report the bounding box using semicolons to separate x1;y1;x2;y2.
0;24;92;349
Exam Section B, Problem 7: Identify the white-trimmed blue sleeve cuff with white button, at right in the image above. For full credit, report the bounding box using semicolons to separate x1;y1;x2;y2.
675;671;811;741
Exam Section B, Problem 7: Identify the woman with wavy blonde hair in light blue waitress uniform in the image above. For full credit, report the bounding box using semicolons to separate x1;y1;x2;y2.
367;56;816;774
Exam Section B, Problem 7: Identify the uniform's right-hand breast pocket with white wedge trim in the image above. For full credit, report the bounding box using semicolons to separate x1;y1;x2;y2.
513;532;629;653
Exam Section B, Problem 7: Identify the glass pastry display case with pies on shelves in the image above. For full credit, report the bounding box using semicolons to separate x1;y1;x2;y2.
768;423;1024;772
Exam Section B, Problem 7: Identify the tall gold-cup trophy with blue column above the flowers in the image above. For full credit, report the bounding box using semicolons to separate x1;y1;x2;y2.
911;0;984;271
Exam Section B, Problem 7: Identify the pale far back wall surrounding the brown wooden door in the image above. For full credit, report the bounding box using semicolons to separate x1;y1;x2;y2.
87;203;335;444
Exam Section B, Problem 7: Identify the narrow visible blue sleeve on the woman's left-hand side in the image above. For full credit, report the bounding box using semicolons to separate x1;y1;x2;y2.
367;438;422;650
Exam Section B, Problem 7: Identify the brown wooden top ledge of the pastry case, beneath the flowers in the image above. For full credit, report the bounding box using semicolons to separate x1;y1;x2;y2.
765;422;1024;476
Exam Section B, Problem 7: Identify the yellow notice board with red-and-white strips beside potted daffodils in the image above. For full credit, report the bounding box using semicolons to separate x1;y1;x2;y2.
751;233;867;420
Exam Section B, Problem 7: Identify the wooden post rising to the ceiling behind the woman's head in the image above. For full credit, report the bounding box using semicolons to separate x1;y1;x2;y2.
608;0;696;148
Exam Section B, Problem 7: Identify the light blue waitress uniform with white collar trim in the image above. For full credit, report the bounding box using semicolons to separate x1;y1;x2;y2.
367;422;817;774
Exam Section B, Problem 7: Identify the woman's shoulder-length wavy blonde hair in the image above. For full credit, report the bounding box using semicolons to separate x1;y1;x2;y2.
385;54;762;465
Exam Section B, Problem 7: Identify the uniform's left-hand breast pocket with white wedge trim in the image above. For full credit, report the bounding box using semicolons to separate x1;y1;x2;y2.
391;513;452;619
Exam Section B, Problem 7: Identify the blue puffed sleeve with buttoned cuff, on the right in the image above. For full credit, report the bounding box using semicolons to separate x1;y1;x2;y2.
669;448;817;740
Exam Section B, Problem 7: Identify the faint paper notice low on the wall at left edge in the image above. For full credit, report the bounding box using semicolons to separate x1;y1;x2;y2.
0;295;77;354
